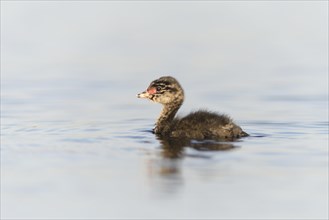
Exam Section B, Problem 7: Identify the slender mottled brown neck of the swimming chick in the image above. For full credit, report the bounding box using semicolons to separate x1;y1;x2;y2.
154;100;183;134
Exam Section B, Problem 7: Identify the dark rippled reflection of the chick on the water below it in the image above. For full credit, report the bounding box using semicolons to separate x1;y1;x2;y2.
147;135;237;195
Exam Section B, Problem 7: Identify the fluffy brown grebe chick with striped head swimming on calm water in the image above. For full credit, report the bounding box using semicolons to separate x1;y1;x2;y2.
137;76;248;140
